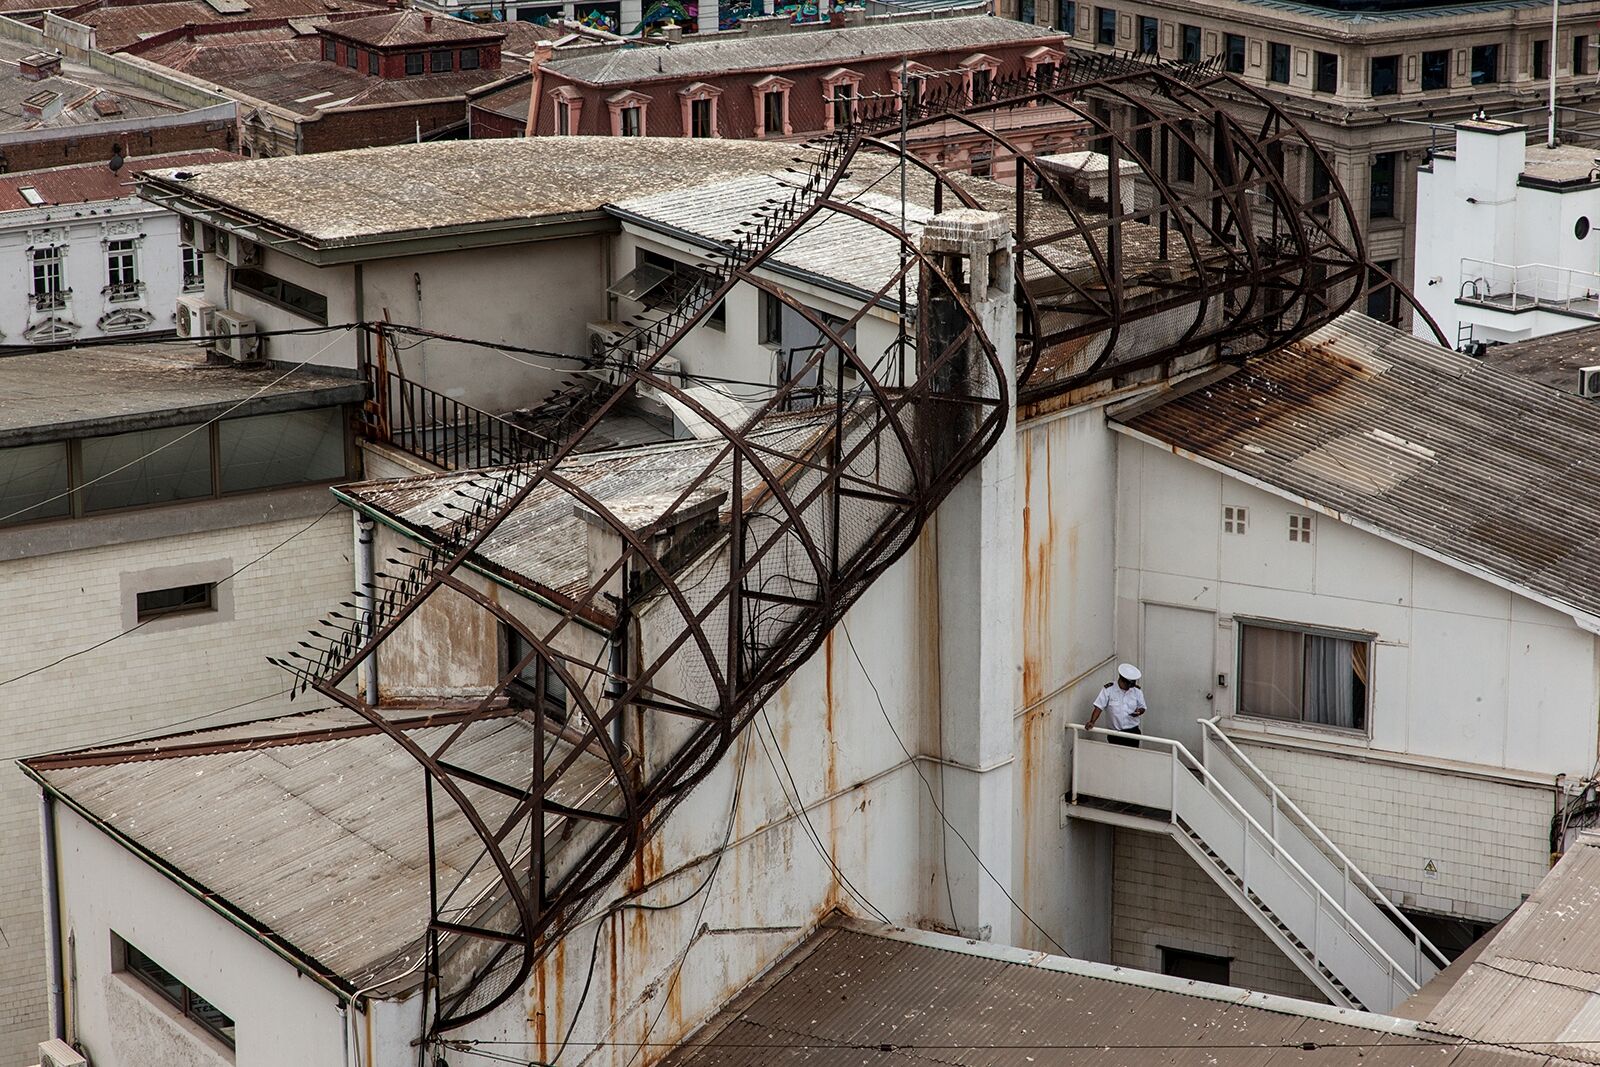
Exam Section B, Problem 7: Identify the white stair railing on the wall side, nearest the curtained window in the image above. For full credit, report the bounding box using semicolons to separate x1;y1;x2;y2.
1200;718;1450;985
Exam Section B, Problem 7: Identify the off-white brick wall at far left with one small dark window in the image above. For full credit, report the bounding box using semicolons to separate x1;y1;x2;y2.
0;490;352;1064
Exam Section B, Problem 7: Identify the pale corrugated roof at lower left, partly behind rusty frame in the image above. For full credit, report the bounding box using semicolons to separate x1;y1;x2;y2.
26;710;611;987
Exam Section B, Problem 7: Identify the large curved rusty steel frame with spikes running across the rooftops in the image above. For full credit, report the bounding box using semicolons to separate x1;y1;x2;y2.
274;56;1366;1038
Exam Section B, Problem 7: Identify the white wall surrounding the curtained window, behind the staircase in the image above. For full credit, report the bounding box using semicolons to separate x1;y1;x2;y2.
1117;438;1600;920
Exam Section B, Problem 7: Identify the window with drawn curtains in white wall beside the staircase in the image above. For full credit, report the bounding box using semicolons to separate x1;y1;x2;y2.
1238;622;1373;731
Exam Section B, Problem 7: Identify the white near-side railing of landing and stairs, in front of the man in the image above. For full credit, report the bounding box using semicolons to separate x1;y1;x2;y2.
1067;723;1419;1011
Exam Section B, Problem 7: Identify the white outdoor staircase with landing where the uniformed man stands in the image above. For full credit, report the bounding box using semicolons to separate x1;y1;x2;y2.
1067;721;1446;1011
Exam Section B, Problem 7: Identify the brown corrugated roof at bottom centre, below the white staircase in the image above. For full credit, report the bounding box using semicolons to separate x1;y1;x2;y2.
666;921;1515;1067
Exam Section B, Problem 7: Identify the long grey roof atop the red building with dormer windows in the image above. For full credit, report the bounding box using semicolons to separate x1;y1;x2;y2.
546;16;1064;86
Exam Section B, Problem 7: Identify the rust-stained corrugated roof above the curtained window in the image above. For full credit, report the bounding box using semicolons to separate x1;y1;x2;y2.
1114;312;1600;624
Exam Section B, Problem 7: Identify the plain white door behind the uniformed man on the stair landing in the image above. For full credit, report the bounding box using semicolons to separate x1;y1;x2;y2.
1138;603;1216;758
